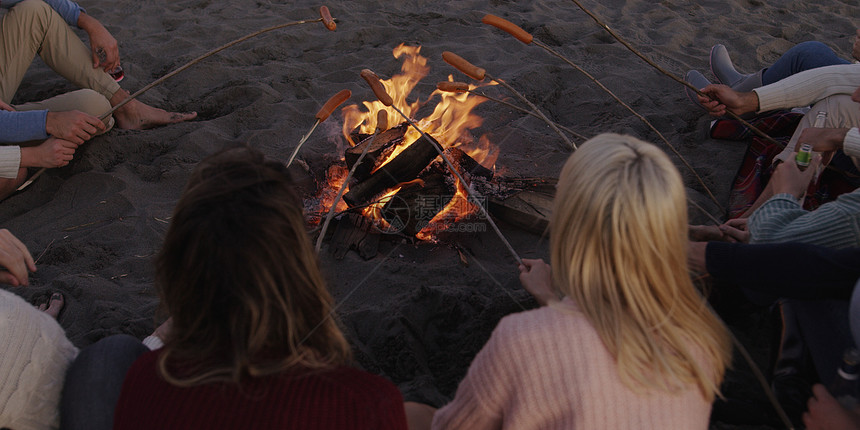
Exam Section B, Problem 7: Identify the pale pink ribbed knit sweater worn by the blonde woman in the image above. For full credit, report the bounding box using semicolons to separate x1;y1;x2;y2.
433;298;711;430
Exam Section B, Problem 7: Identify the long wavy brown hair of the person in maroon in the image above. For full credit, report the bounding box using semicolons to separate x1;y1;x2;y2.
156;147;351;386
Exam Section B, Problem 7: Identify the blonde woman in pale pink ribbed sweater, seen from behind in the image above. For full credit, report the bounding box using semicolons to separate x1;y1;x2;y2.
407;134;731;429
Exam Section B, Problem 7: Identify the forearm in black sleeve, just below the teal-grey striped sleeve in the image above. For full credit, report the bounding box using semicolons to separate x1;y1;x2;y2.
705;242;860;299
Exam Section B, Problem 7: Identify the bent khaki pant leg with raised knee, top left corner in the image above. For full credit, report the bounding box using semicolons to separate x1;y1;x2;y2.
0;0;120;103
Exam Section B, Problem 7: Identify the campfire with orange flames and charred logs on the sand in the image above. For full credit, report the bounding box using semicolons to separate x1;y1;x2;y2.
312;44;498;249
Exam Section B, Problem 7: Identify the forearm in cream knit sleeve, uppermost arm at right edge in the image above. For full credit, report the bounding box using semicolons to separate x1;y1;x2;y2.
753;64;860;111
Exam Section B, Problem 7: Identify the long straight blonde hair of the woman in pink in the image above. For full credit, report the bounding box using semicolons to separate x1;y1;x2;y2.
550;134;731;400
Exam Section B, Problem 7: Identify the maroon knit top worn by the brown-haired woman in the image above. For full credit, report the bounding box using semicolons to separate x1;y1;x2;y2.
114;350;406;430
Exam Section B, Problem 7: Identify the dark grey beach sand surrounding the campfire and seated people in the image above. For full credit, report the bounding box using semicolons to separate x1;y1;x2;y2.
0;0;857;428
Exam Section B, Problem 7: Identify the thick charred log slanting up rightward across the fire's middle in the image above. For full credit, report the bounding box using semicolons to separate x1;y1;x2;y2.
343;127;442;206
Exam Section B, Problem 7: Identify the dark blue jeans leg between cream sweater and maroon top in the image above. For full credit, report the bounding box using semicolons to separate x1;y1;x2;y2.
60;334;149;430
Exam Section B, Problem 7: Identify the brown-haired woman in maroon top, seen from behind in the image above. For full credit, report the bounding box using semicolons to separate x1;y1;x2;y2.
114;148;406;430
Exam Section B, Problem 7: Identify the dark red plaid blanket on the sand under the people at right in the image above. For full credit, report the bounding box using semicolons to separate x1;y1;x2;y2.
711;110;860;218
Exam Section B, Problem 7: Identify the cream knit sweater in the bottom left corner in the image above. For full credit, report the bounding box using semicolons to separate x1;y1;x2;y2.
0;289;78;430
